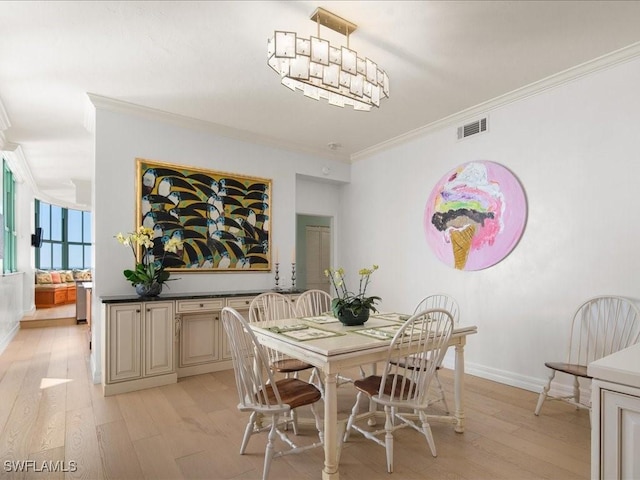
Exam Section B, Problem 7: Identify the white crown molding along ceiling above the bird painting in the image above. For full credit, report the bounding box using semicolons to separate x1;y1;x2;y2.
85;93;350;163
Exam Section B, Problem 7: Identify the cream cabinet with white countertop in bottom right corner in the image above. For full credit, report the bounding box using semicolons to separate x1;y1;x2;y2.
588;345;640;480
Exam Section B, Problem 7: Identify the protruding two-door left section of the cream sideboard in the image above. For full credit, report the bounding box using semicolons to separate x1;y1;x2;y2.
103;301;177;395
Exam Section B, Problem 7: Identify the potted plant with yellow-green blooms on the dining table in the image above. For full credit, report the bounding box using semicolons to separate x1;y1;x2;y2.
324;265;381;325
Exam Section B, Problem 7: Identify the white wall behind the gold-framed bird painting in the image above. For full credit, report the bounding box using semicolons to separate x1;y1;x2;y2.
92;106;350;381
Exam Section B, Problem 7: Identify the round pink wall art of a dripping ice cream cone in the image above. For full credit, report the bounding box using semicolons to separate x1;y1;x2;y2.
424;161;527;270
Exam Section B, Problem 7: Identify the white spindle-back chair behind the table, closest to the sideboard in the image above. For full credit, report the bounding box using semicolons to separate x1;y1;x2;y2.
249;292;324;433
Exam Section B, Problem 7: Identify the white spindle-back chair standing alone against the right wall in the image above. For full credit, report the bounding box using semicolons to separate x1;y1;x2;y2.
534;296;640;418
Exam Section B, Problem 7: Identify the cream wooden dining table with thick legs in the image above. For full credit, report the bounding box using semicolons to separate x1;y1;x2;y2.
251;316;477;480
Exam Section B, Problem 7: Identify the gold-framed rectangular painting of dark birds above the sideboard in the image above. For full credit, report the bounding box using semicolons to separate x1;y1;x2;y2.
136;158;271;272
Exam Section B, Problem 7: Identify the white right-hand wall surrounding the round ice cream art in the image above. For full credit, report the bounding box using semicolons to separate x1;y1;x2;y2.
339;59;640;394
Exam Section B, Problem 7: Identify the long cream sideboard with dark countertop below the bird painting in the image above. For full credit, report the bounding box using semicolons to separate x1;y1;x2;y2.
101;292;299;395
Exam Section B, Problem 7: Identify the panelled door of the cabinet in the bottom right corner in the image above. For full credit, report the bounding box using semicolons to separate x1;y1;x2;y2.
600;390;640;479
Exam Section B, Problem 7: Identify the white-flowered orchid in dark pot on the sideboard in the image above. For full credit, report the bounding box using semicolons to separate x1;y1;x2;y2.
115;226;183;297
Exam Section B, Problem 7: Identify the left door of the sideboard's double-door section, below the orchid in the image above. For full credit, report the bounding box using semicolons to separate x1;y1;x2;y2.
107;304;142;383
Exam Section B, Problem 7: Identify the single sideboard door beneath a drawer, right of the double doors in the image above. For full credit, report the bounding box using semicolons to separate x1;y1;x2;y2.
180;312;222;367
